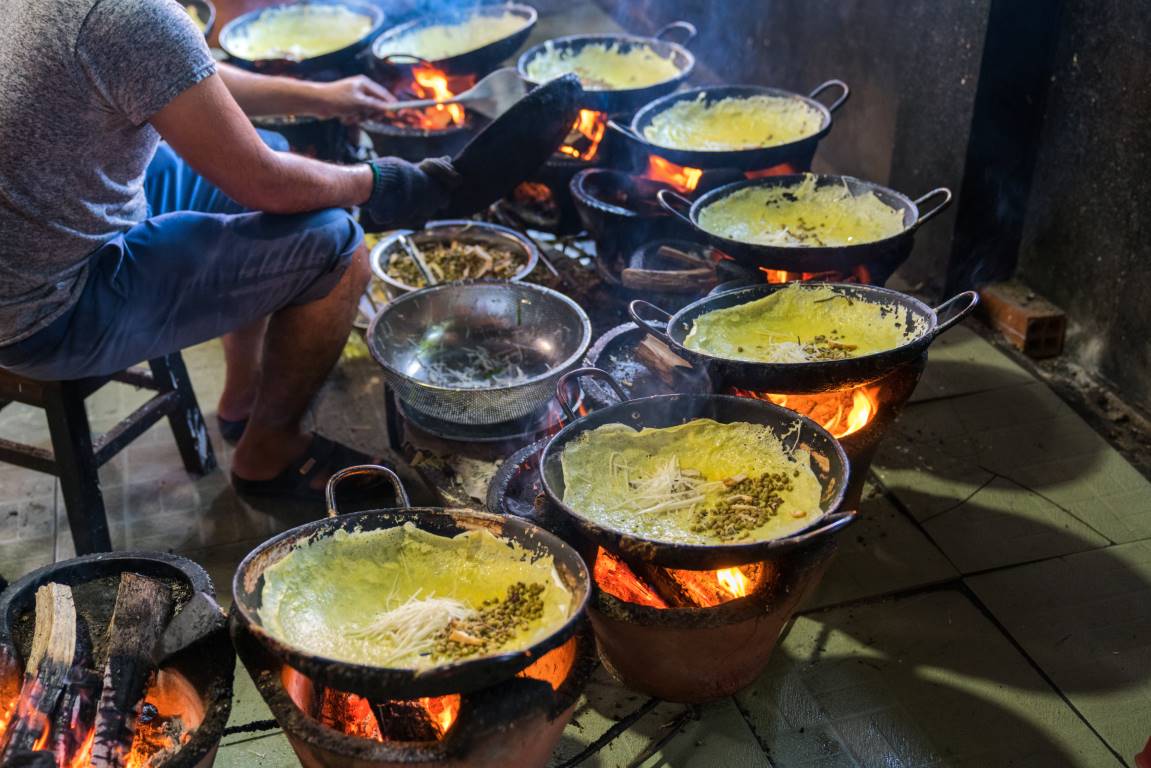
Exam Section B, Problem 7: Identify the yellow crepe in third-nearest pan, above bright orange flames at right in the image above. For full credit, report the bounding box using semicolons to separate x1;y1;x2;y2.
684;283;925;363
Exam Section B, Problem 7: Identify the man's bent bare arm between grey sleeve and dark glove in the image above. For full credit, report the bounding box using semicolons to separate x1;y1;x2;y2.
151;75;373;213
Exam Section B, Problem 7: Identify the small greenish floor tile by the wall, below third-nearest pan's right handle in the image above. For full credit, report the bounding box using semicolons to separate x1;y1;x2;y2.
912;325;1034;402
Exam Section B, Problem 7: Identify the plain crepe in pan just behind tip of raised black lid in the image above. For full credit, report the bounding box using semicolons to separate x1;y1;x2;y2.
527;43;679;91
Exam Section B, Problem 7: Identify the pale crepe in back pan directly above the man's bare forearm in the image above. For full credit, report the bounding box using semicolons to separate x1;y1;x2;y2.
229;3;372;61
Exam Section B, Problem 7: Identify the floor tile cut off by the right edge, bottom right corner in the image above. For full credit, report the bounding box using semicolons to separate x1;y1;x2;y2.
969;541;1151;760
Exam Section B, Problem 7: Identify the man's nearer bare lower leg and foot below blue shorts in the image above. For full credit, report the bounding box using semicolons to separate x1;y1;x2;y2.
231;245;371;484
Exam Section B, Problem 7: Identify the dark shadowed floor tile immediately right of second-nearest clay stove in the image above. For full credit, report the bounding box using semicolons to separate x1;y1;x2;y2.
802;486;959;610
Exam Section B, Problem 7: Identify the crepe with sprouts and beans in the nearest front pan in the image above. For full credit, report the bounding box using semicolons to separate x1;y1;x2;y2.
260;524;572;669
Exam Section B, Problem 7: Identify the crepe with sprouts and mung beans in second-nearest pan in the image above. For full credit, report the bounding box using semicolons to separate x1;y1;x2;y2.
561;419;822;545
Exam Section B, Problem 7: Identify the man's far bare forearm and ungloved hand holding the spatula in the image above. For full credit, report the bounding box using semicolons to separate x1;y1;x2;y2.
216;63;395;120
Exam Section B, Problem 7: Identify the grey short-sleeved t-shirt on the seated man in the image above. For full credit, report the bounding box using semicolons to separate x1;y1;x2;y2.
0;0;215;345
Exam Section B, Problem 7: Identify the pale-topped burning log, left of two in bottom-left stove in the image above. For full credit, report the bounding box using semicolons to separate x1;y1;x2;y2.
0;584;76;766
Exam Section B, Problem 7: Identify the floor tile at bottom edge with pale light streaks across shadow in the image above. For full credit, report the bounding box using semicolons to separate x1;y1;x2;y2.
737;590;1118;768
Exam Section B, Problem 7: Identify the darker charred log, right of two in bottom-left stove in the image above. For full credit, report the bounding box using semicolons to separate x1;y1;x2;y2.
91;573;173;768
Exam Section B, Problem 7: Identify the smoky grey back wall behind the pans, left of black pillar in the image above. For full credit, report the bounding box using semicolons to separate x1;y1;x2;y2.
601;0;991;292
